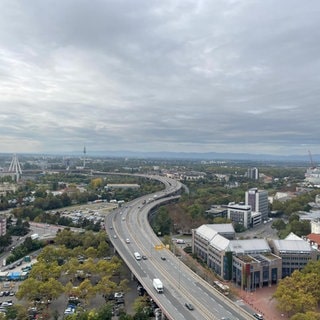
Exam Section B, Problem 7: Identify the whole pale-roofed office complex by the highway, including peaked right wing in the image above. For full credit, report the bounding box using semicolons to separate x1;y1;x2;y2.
192;224;320;291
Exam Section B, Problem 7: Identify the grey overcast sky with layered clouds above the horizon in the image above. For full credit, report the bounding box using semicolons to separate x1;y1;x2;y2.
0;0;320;157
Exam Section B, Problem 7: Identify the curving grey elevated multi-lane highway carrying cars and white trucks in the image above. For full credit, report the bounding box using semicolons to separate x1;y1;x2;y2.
105;177;253;320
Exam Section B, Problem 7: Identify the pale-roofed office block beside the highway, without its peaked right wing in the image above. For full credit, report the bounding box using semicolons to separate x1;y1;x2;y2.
192;224;282;290
